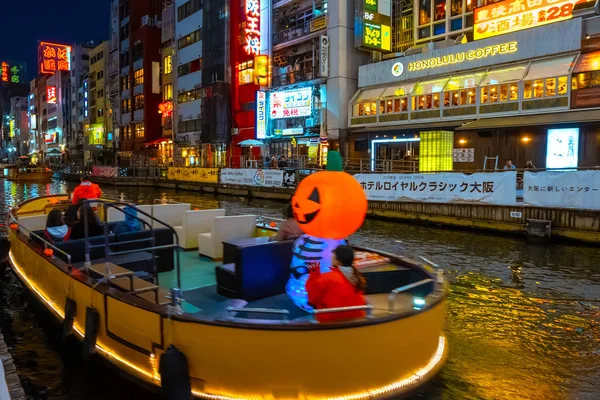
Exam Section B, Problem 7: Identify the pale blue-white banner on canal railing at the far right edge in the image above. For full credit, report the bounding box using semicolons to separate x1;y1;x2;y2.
523;171;600;210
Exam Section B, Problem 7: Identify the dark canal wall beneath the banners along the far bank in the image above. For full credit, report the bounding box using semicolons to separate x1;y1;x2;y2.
59;174;600;243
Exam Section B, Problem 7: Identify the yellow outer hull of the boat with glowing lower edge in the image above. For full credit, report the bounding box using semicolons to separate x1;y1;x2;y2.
9;200;447;399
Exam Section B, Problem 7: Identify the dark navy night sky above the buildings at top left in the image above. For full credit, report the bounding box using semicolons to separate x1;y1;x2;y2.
0;0;110;79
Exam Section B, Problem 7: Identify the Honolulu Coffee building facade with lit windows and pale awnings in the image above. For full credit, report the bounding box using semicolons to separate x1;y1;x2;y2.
348;2;600;171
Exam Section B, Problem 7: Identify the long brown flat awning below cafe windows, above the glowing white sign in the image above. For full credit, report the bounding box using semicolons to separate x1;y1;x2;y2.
456;110;600;131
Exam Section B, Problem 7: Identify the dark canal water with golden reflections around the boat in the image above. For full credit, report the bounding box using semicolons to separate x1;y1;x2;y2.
0;180;600;400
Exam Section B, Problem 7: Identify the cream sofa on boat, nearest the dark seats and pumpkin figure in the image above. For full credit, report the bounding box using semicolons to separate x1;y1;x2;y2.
198;215;256;260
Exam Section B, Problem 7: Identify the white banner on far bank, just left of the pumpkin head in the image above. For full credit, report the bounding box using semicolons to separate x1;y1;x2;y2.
221;168;296;187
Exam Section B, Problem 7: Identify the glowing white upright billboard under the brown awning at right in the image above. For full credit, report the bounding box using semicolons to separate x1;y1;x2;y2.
546;128;579;168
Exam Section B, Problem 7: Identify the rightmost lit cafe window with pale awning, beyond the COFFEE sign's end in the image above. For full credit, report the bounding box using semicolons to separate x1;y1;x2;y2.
523;56;575;100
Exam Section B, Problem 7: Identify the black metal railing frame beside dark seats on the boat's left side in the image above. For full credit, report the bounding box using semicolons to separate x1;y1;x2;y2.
84;201;181;287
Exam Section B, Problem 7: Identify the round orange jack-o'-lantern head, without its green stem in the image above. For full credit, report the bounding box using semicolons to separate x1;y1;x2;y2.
292;171;367;239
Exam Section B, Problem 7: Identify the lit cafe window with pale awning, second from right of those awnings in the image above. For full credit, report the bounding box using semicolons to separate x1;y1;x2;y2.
480;63;529;104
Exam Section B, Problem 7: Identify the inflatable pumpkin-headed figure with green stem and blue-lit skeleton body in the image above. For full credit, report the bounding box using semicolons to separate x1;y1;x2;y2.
286;151;367;311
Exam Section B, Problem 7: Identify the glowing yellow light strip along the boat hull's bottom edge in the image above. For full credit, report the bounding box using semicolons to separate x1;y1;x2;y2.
9;251;446;400
